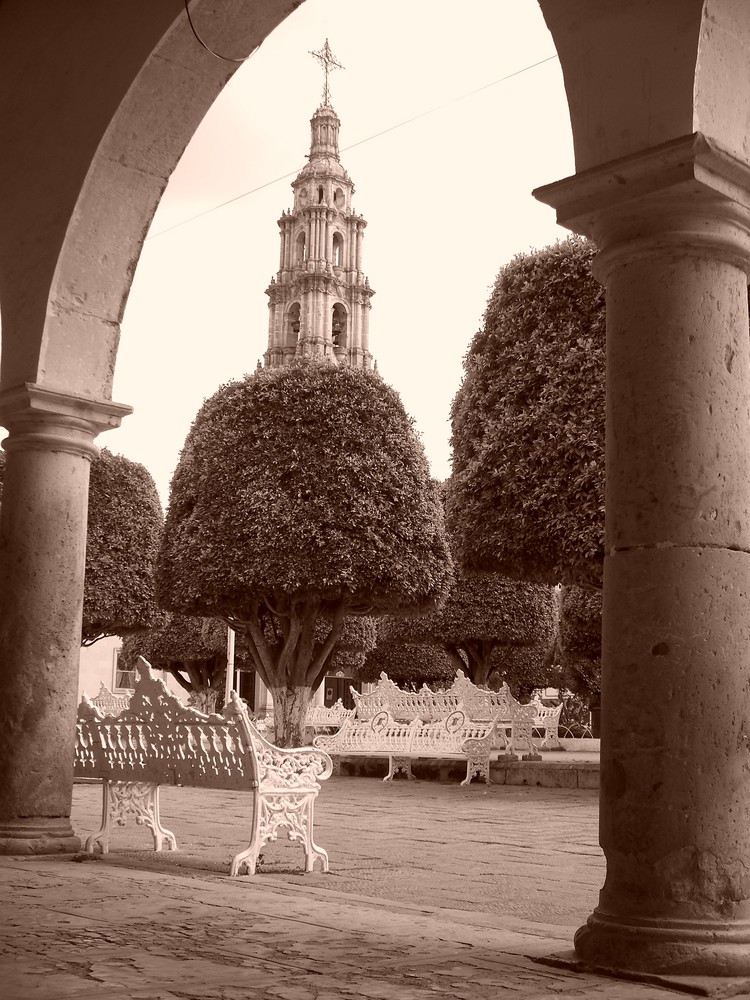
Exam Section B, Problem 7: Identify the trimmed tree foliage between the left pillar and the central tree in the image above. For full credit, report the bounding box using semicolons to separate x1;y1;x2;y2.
0;448;164;646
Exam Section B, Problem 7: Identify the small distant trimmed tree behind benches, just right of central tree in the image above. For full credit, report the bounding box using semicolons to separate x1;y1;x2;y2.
380;573;557;686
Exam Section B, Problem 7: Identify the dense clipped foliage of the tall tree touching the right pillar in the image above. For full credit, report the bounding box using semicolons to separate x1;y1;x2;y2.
448;237;605;586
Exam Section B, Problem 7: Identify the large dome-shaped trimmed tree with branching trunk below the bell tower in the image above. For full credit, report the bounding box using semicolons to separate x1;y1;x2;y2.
157;361;451;746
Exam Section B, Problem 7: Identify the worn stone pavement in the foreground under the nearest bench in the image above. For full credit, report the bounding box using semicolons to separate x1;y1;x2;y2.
0;778;748;1000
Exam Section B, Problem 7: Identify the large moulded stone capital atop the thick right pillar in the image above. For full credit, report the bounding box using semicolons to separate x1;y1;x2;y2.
533;132;750;278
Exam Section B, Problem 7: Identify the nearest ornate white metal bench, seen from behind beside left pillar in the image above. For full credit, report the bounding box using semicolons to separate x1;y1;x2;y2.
75;658;332;876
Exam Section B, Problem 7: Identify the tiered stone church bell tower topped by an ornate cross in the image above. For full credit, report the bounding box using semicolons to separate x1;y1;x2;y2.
264;39;374;369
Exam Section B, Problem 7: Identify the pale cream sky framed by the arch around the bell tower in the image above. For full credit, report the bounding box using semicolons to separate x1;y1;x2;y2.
108;0;574;506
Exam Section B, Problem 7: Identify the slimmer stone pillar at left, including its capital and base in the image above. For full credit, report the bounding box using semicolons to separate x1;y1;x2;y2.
0;385;130;854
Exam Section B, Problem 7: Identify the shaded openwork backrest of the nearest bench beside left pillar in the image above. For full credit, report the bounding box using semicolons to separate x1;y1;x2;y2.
75;657;257;789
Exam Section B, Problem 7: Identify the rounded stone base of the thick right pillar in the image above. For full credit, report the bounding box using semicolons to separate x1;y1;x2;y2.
574;910;750;976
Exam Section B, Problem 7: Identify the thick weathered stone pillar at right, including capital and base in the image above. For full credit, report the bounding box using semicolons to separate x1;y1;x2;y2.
537;129;750;976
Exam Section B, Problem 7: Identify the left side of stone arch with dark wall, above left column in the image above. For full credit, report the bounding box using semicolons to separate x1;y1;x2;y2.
0;0;295;399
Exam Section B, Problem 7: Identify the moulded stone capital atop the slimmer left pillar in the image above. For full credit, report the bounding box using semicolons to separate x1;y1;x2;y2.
0;382;133;458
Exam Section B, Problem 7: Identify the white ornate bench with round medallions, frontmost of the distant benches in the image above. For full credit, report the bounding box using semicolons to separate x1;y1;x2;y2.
313;708;513;785
